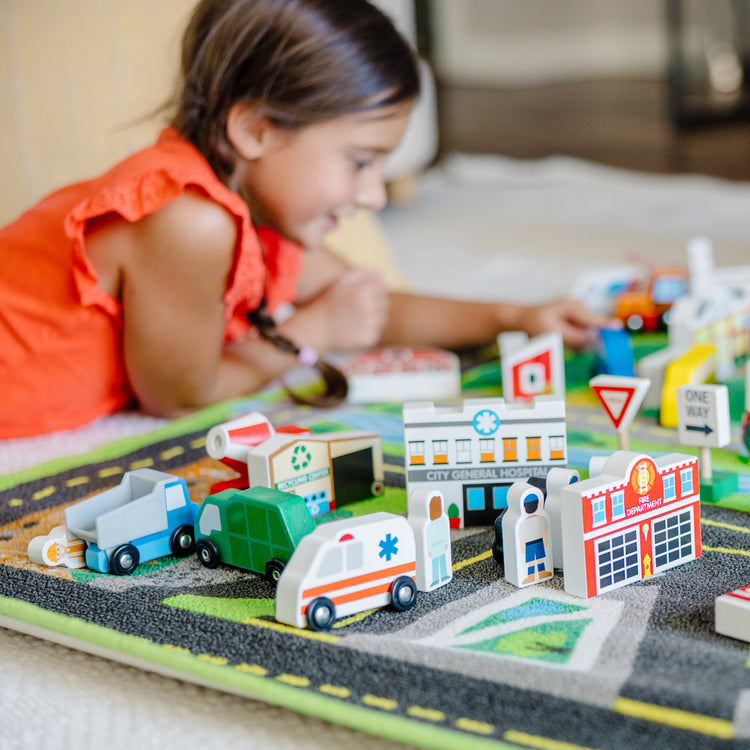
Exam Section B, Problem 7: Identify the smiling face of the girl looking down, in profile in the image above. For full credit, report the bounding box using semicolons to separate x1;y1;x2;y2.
238;103;412;248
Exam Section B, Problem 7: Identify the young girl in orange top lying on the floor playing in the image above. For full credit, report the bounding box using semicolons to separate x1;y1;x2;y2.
0;0;602;438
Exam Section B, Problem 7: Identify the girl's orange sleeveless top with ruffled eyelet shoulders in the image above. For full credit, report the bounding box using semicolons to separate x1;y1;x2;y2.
0;129;302;438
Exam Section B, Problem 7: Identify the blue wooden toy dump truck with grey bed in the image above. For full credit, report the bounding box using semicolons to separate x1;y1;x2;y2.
65;469;200;575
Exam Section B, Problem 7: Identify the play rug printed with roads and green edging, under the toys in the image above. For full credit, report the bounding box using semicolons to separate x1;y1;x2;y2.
0;352;750;750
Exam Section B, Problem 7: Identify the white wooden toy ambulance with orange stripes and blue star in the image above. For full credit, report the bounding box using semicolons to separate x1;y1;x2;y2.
276;512;417;631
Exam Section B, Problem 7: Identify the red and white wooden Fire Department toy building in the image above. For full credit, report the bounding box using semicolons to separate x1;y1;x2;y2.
560;451;701;598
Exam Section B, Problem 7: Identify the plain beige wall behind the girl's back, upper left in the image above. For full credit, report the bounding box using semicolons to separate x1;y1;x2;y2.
0;0;195;225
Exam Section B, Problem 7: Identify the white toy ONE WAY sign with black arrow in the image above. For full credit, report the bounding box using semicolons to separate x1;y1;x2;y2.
677;384;731;448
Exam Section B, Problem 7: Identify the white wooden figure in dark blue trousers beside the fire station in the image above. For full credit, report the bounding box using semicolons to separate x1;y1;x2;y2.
502;482;553;587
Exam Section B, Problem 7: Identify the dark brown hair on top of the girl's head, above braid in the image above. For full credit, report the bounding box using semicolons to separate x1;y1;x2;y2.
172;0;419;182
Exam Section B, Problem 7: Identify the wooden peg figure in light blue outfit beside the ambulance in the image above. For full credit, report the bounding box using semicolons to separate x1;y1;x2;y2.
407;487;453;591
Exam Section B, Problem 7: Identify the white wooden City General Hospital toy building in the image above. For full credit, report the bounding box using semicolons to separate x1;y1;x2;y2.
403;396;567;528
